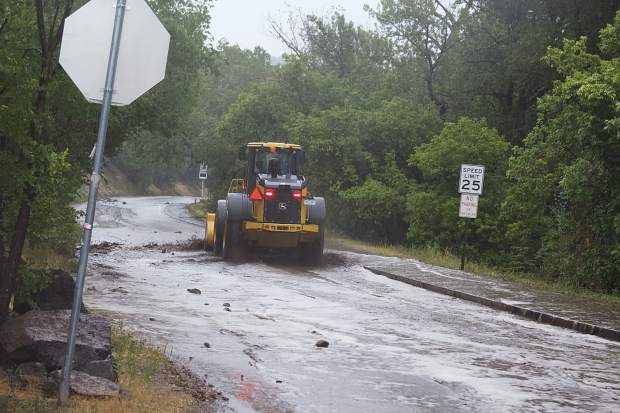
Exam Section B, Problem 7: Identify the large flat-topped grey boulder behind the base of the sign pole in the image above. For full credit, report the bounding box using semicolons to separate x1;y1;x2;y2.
0;310;111;370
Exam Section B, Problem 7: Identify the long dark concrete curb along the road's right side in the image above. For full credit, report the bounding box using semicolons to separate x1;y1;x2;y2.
364;266;620;342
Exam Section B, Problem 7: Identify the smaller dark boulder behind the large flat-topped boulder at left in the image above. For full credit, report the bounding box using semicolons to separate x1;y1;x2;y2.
15;270;87;314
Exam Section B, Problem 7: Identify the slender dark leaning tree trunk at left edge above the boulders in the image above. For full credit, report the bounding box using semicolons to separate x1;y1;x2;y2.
0;193;30;323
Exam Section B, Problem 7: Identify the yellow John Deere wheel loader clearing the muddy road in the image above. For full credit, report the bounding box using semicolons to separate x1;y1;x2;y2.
205;142;326;264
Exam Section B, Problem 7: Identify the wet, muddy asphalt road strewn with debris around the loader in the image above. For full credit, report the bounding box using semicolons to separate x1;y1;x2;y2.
85;197;620;413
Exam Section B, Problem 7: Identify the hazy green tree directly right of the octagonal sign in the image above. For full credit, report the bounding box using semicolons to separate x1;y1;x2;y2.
111;0;217;188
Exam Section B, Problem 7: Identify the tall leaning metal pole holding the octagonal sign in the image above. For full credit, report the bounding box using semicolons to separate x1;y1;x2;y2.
60;0;127;405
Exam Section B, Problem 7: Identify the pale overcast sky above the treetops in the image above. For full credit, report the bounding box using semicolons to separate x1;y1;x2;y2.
211;0;379;56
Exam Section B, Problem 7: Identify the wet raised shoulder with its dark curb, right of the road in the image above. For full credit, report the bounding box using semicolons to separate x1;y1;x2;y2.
330;233;620;342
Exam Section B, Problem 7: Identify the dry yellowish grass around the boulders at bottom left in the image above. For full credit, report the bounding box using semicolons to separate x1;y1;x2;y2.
0;326;210;413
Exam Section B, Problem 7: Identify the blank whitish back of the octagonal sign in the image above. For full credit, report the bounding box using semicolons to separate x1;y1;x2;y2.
60;0;170;106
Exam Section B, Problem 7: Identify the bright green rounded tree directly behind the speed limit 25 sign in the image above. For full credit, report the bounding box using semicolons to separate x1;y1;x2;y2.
407;118;509;260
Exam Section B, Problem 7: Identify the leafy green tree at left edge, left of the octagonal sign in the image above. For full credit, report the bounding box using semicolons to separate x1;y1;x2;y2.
0;0;82;322
